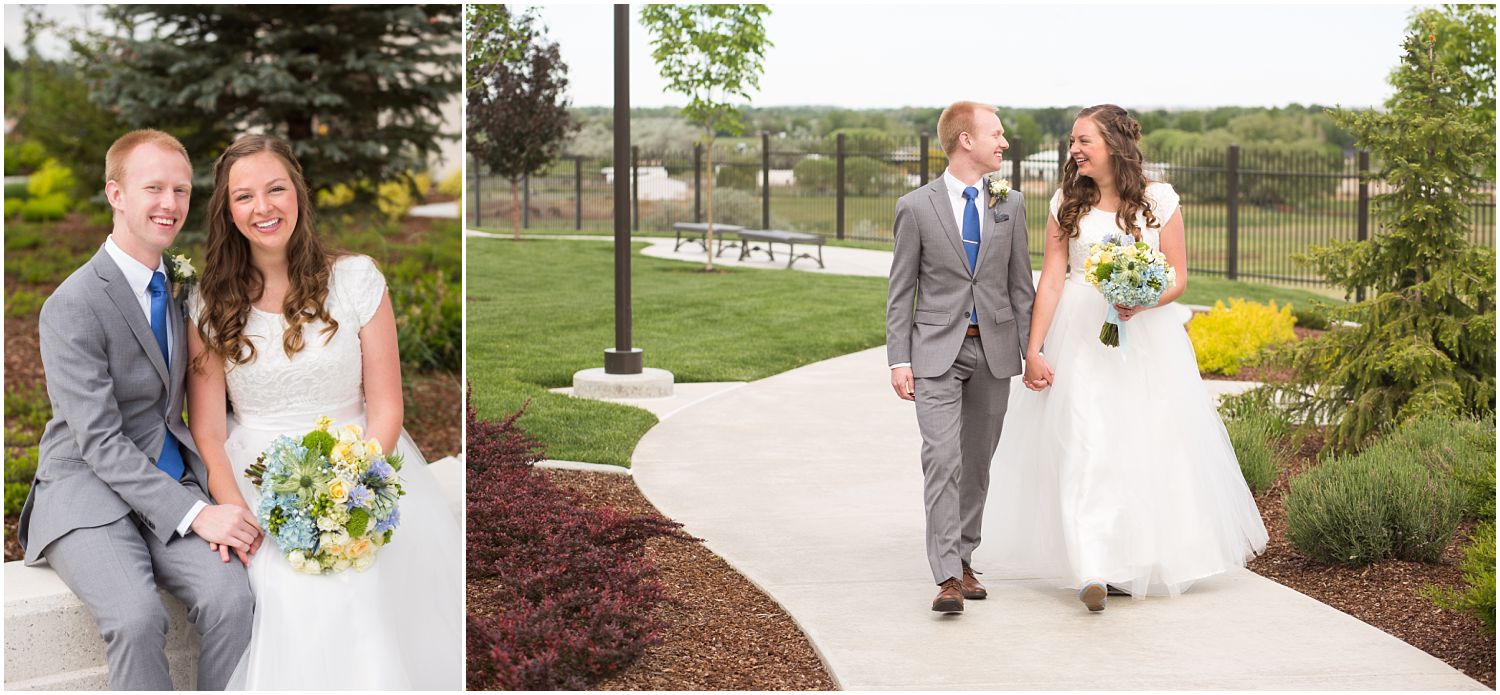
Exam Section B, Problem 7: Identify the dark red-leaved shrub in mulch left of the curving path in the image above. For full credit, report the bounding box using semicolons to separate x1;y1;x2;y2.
467;390;687;690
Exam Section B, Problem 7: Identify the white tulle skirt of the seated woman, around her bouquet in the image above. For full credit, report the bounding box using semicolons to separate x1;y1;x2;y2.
225;404;464;690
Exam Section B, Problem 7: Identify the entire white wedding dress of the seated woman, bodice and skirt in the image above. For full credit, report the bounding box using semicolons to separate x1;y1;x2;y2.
189;255;464;690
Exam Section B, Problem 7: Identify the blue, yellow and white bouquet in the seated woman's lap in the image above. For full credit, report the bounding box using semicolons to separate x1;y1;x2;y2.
245;417;405;575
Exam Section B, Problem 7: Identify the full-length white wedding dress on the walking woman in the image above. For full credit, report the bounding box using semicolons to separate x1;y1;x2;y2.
984;183;1266;597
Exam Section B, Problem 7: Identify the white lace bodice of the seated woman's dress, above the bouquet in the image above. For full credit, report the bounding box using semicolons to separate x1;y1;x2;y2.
188;255;386;423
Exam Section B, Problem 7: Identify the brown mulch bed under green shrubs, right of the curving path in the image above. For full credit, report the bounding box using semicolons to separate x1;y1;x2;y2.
1248;437;1496;689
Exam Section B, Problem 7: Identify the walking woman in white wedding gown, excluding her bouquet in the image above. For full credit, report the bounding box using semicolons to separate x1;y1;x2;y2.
990;105;1266;611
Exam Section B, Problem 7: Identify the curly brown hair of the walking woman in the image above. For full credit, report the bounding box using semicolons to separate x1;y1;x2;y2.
1058;104;1161;242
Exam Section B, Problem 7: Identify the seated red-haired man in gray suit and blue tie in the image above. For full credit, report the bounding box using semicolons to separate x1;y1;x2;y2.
20;131;260;690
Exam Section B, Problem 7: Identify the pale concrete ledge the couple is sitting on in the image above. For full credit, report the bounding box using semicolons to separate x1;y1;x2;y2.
5;453;464;690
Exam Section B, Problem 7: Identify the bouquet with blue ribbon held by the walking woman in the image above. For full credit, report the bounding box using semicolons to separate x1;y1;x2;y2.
1083;234;1178;347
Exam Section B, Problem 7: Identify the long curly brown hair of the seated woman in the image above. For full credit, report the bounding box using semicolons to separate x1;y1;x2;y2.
194;135;341;375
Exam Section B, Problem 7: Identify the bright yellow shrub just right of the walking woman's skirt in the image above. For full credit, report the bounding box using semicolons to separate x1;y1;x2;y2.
1188;299;1296;374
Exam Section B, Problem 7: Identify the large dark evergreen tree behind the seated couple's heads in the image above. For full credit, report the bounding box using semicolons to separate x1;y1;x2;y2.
75;5;462;207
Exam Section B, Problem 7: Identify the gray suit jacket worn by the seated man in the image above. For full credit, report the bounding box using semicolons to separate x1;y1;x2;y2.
18;248;209;564
